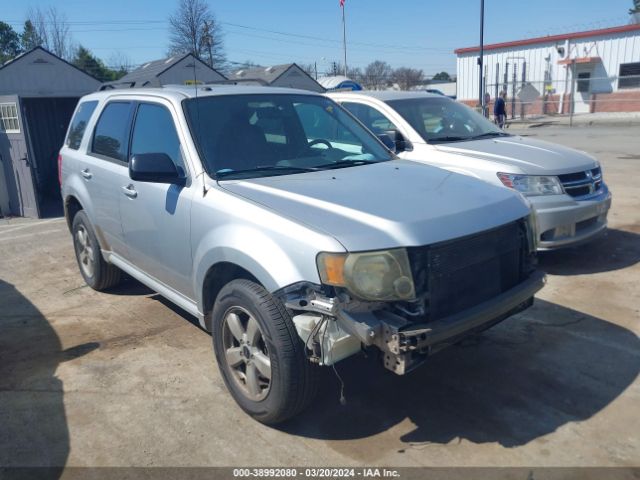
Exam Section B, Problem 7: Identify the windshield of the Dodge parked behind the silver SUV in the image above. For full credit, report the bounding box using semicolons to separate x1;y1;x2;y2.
387;97;507;143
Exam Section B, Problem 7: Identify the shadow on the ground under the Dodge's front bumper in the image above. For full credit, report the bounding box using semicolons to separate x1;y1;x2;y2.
538;226;640;275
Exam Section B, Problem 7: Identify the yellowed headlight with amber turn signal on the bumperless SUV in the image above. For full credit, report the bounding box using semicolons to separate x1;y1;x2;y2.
317;248;415;301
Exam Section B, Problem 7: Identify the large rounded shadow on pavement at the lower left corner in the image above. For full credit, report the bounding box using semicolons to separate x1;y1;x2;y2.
0;280;79;478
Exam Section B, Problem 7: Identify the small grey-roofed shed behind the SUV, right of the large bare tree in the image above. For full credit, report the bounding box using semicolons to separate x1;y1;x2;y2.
229;63;325;93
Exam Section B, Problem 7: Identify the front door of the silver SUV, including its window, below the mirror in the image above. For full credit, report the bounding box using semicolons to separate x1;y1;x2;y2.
118;99;194;298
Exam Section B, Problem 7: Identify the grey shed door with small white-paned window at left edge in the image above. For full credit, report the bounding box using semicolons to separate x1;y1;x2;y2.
0;95;38;218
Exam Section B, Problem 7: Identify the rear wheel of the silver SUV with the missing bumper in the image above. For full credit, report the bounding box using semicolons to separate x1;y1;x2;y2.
71;210;121;291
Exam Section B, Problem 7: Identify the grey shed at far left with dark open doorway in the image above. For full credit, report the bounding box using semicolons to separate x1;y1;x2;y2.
0;47;100;218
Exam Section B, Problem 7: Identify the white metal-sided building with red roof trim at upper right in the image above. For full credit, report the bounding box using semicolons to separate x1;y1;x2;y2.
455;24;640;114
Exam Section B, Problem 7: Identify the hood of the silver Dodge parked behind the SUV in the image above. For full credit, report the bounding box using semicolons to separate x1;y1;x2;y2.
434;135;598;175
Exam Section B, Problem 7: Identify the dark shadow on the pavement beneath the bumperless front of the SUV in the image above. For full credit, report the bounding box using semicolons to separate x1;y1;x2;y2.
280;300;640;455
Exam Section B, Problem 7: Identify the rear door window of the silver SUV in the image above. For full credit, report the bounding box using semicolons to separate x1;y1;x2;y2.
91;102;131;162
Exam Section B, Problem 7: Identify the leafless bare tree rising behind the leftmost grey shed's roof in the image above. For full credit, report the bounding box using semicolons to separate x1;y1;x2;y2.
27;7;74;60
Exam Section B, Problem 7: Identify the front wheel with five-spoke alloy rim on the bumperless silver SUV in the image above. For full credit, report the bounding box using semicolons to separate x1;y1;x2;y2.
212;280;318;425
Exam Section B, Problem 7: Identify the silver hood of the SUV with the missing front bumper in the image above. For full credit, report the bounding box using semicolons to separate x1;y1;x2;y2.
220;160;529;251
